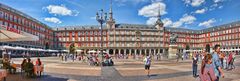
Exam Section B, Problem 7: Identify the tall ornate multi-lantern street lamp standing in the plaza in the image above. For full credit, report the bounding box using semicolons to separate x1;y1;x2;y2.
96;9;107;63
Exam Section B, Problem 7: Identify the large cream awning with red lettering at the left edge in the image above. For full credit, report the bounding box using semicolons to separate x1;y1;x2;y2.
0;25;39;42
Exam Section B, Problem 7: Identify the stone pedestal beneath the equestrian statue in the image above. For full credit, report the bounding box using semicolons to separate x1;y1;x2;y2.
168;45;178;59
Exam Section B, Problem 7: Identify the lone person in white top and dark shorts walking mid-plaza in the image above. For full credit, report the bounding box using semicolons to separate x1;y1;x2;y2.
143;54;151;77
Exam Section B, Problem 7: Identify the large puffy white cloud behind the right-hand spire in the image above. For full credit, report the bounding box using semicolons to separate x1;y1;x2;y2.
138;2;167;17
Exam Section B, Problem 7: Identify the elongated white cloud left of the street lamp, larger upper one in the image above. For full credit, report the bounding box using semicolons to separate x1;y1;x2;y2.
46;5;79;16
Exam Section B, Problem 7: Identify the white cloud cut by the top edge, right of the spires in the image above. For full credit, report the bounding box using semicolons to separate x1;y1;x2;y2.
183;0;205;7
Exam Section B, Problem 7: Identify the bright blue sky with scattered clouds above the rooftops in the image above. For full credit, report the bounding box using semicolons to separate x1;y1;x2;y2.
0;0;240;29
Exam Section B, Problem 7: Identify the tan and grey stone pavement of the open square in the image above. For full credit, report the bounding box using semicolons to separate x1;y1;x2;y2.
4;56;240;81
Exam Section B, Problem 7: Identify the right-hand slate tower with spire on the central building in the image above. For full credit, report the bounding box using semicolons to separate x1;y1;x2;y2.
155;5;163;30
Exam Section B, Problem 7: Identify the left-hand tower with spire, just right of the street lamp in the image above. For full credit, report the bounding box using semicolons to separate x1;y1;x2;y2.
107;0;115;29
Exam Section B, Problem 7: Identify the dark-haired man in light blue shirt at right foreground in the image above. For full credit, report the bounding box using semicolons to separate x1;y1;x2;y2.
212;44;224;81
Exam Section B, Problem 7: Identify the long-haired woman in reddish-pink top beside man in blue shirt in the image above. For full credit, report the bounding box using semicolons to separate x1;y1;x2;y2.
199;54;217;81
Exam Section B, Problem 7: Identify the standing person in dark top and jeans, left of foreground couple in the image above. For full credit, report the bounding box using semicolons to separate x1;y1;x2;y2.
192;53;198;77
